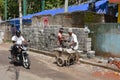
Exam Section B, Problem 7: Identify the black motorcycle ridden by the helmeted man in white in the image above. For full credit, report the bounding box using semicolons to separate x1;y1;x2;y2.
10;45;30;69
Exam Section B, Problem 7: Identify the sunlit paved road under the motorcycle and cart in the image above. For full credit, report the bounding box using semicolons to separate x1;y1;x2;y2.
0;44;120;80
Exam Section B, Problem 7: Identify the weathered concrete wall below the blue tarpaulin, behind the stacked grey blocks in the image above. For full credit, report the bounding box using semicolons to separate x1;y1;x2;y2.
32;11;117;28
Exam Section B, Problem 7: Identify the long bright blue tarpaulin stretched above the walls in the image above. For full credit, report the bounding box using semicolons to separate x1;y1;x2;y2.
9;0;108;26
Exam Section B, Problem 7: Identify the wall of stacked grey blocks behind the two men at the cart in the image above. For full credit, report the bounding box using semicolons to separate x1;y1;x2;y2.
23;25;91;51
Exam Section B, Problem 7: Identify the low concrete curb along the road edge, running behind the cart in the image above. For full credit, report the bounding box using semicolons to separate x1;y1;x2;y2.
29;48;120;72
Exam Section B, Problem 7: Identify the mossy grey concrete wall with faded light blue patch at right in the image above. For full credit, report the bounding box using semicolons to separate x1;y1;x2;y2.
89;23;120;56
